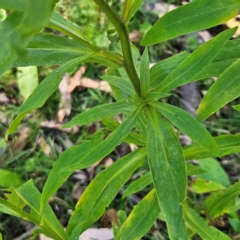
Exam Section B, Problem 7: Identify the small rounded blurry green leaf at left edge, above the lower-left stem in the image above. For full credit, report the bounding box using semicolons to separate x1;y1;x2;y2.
0;169;23;188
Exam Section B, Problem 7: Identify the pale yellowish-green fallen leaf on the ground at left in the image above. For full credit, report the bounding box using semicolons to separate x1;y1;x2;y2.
17;66;38;100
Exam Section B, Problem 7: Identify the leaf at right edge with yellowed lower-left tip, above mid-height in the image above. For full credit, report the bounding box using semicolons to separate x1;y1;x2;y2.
197;59;240;122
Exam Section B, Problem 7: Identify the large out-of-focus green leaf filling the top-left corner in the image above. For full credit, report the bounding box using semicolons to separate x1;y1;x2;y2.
0;0;57;76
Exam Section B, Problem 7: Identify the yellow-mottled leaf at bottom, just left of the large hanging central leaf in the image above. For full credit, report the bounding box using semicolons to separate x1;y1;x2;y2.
115;189;159;240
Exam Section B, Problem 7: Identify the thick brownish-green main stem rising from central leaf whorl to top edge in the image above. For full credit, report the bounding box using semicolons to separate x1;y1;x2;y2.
93;0;141;97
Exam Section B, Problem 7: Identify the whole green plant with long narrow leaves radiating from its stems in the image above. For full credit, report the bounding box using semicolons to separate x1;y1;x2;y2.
0;0;240;240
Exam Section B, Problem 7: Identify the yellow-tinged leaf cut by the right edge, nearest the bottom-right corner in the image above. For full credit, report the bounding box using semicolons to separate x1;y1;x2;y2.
204;182;240;219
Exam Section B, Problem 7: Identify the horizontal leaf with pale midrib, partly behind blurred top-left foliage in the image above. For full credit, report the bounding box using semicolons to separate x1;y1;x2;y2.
13;33;94;66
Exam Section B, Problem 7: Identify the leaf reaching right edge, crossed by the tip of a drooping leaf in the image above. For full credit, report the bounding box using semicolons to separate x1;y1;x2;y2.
183;134;240;160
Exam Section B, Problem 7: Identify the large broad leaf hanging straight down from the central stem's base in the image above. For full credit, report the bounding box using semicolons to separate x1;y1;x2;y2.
147;108;187;240
